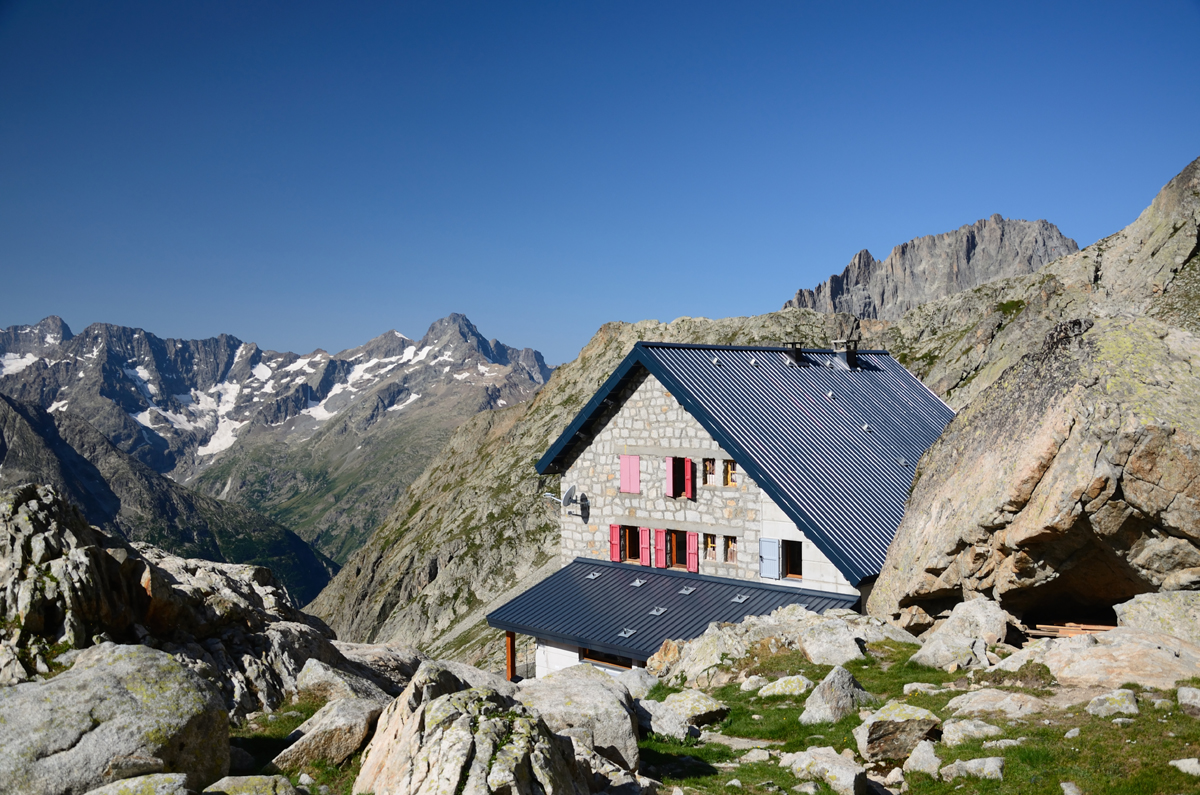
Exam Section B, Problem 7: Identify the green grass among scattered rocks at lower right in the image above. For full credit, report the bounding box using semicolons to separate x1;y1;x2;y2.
640;641;1200;795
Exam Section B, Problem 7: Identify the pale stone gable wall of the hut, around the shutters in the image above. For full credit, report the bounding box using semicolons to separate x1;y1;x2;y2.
560;375;858;594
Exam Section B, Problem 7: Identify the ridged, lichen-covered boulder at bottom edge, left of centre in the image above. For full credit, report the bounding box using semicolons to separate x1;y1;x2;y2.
354;682;590;795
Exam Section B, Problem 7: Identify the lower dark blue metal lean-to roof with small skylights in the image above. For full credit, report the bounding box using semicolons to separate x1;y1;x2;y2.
487;557;858;659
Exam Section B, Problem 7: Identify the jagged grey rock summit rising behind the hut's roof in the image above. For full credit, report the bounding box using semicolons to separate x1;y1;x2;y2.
784;215;1079;321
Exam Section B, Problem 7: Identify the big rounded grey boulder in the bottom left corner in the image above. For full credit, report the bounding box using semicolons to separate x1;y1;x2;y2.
0;644;229;795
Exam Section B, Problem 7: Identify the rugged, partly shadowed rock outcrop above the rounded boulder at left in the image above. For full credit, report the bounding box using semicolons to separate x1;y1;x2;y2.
0;485;407;717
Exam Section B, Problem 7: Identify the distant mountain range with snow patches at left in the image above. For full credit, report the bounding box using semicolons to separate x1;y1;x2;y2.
0;315;552;566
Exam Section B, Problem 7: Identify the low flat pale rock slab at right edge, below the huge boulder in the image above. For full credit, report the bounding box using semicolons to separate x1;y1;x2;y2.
994;627;1200;689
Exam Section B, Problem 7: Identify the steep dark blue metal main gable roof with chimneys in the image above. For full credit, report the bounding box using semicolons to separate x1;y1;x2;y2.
538;342;954;585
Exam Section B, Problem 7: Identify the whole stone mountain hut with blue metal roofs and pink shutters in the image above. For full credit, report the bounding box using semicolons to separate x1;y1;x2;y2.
488;341;954;676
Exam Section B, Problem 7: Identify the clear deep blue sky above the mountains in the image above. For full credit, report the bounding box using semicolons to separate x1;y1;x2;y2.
0;0;1200;363
